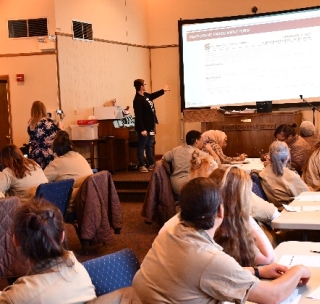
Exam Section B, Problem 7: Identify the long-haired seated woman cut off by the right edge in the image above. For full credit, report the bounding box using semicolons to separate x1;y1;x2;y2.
302;142;320;191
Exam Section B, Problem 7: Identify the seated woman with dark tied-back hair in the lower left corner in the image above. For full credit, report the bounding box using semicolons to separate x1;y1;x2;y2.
0;199;96;304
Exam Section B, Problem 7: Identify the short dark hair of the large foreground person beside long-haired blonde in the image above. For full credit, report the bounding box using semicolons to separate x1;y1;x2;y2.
179;177;222;230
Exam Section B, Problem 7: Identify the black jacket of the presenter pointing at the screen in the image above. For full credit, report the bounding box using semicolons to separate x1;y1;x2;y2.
133;90;164;133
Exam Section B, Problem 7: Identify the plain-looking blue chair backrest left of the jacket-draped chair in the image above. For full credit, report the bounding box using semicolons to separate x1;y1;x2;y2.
35;179;74;215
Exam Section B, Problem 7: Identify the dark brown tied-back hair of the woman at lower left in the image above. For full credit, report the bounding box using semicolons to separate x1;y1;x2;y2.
13;199;67;266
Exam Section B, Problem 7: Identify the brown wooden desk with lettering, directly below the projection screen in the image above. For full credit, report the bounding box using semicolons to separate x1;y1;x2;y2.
201;111;302;157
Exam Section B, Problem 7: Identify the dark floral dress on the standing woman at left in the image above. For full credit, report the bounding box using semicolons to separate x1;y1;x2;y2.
28;118;60;169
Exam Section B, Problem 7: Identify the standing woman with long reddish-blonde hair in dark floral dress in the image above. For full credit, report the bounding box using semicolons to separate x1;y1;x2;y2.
28;101;60;169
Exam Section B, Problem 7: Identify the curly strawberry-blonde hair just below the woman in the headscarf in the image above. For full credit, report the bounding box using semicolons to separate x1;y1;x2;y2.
189;149;218;179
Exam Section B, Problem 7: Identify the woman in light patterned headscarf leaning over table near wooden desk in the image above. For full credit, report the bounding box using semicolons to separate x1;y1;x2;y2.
201;130;247;164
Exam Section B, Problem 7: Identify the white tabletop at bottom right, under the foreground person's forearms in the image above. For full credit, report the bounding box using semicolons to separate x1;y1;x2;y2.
275;241;320;304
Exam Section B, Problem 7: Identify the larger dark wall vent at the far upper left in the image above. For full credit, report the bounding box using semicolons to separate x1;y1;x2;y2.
8;18;48;38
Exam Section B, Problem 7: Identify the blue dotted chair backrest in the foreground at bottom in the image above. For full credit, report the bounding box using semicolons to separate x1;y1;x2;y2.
83;248;140;296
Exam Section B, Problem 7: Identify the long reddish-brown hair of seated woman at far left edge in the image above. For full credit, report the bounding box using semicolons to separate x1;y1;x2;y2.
1;145;38;179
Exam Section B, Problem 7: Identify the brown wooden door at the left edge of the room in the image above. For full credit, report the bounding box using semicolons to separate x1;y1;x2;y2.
0;76;12;149
